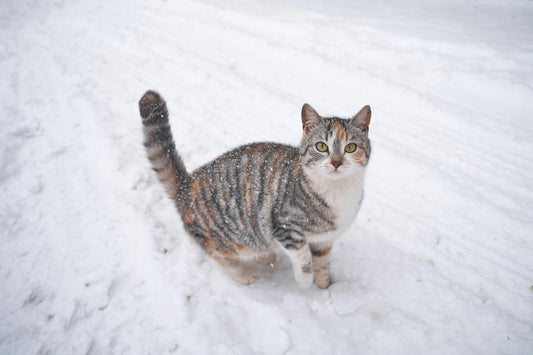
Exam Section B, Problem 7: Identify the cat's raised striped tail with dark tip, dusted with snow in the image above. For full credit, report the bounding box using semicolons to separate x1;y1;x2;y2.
139;91;190;212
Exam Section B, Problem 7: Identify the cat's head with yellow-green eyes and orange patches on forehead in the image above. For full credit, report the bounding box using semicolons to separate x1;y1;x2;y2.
300;104;371;180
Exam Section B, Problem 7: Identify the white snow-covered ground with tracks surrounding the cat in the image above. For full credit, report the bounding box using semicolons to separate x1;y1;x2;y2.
0;0;533;355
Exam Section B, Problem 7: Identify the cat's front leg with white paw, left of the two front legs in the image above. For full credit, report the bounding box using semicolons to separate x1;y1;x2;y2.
275;232;313;288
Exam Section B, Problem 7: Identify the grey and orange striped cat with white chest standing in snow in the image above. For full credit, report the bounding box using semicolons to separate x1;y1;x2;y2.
139;91;371;289
